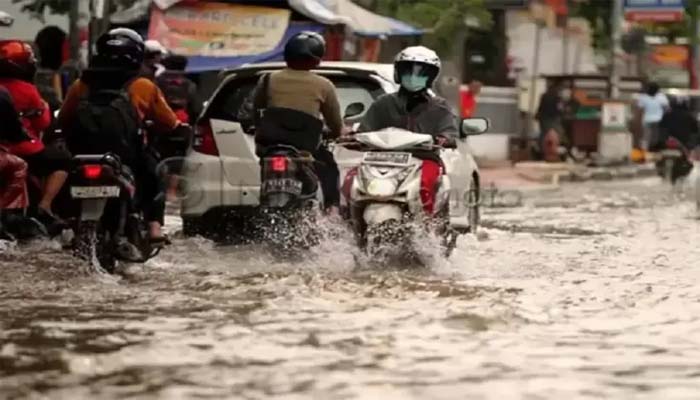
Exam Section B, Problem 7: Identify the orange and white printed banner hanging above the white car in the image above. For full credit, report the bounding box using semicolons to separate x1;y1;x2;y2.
148;2;291;57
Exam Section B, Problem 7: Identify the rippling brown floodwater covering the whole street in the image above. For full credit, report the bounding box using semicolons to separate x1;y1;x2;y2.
0;179;700;400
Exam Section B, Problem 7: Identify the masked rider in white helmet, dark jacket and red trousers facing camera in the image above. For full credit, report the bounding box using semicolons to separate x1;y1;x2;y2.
360;46;459;215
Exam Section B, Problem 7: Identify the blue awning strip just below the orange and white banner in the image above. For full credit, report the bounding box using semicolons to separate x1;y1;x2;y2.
187;22;323;72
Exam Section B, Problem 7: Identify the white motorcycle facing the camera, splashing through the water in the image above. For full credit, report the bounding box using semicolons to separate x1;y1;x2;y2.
338;129;458;257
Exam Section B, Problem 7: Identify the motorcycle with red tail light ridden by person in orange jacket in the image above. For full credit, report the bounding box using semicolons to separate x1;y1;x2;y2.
68;153;161;273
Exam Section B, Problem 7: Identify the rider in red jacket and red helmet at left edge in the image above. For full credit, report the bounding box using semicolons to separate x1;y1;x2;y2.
0;40;71;233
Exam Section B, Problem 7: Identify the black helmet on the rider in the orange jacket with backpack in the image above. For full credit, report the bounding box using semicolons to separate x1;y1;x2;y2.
95;28;145;69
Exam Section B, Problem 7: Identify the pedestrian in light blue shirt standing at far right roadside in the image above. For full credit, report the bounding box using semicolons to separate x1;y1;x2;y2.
637;82;670;152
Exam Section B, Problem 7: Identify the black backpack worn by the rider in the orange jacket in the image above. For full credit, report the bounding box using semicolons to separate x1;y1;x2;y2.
68;81;145;165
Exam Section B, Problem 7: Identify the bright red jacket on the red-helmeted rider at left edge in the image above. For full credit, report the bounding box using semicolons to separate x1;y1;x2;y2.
0;78;51;156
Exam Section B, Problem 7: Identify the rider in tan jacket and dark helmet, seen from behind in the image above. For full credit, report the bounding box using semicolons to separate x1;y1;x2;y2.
253;32;345;214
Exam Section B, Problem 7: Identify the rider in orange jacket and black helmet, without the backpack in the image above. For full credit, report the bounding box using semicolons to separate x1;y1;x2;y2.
58;28;190;244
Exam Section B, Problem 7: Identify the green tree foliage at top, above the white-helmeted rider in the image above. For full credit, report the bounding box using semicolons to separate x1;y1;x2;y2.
355;0;492;56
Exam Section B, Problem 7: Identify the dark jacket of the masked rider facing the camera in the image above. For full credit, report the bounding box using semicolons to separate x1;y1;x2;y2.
359;91;459;137
